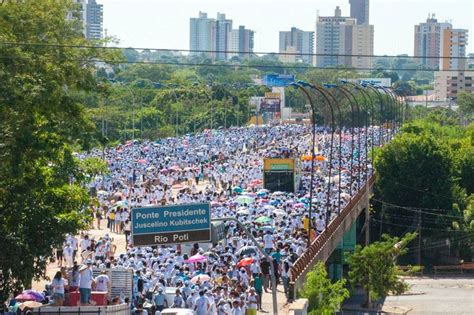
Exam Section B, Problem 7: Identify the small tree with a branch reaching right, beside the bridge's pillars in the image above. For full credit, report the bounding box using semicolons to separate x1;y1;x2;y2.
349;233;416;307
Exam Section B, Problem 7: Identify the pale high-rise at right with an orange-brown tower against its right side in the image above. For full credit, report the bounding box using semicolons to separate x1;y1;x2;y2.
415;14;452;69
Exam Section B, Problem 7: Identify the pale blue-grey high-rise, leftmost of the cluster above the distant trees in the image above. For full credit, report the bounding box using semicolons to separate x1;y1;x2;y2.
189;12;216;55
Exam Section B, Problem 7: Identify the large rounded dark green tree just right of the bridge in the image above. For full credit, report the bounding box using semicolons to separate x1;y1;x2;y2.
375;130;456;235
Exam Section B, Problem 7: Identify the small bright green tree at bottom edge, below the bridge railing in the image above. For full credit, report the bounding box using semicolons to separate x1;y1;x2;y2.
301;262;349;315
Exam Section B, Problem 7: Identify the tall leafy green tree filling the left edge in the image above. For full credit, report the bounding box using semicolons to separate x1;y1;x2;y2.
0;0;116;296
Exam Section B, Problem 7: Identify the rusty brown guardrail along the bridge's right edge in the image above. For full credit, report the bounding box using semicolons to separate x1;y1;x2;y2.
290;175;375;283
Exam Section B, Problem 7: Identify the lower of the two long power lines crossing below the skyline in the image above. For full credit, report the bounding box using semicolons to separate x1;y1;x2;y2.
0;56;461;72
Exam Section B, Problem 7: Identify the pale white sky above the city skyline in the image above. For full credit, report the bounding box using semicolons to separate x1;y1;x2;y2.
97;0;474;55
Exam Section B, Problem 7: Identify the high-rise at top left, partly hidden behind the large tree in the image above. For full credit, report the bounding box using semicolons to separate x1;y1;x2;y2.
67;0;104;39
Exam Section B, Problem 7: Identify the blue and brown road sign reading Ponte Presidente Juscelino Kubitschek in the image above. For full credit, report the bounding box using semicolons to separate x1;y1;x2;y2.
132;203;211;246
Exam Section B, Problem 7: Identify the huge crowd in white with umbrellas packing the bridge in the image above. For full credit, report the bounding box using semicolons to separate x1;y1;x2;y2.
47;125;379;315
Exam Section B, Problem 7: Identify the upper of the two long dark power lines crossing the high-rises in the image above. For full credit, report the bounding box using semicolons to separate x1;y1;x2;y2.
0;42;469;60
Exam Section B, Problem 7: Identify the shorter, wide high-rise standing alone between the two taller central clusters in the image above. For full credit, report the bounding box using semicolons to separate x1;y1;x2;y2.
279;27;314;64
